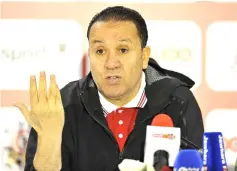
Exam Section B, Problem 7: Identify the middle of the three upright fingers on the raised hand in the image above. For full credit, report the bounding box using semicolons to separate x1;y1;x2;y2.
39;72;47;102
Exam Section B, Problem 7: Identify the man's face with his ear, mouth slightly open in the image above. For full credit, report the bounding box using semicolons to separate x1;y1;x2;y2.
88;20;150;100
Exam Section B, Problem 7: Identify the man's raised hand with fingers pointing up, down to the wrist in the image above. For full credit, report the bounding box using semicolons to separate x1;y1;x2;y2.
14;72;64;138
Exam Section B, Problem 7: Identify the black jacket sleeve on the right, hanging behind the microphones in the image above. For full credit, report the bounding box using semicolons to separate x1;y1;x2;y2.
173;87;204;147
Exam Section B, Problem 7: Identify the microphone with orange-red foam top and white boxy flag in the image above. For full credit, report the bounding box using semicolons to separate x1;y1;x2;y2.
144;114;181;167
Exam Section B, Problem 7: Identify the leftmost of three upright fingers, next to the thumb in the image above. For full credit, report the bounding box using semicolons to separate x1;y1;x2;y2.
30;76;39;108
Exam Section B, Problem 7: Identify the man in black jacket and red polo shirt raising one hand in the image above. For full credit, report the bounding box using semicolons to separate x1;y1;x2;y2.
16;6;204;171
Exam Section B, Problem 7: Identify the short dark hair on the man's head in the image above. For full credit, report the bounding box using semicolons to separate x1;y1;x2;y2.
87;6;148;48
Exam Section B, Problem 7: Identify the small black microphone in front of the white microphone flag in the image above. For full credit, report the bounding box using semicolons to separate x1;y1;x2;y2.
153;150;169;171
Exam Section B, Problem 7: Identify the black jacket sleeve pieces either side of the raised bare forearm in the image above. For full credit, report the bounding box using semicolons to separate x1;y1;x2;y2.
24;123;71;171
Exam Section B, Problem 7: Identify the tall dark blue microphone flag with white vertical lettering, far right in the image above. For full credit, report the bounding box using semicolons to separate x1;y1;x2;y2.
203;132;227;171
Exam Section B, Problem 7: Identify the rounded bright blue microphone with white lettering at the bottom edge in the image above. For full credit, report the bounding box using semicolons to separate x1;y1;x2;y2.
174;149;203;171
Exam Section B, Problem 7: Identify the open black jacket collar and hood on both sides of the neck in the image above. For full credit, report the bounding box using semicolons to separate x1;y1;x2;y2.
80;58;194;125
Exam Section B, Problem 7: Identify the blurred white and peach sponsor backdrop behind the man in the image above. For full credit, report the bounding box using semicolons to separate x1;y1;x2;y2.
0;0;237;171
